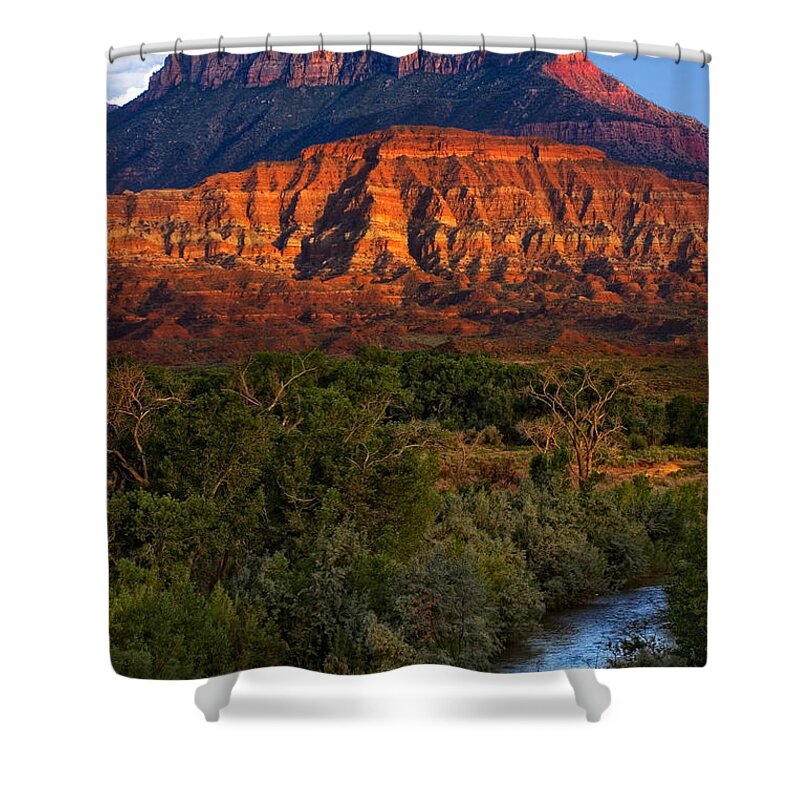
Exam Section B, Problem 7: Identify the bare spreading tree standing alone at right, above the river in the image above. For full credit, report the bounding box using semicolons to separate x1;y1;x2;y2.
526;363;634;486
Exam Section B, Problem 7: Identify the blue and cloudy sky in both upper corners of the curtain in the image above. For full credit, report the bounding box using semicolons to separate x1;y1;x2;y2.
106;53;709;125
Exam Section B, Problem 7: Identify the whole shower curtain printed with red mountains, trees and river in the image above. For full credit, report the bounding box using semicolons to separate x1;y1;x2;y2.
107;50;709;679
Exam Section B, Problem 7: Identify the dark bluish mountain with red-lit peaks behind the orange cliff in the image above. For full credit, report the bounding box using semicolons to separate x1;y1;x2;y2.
108;51;708;192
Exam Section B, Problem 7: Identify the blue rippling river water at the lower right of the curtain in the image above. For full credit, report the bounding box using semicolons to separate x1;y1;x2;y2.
493;586;669;672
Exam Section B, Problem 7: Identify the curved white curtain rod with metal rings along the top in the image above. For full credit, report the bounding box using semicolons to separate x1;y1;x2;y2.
107;33;711;67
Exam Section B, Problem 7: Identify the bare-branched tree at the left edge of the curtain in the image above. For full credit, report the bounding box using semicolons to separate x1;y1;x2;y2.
108;363;180;486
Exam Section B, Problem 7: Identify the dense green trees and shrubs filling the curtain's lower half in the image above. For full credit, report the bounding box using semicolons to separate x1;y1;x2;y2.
108;348;705;678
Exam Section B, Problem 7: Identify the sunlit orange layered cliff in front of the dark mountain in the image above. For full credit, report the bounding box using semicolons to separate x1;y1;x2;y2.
108;125;708;363
